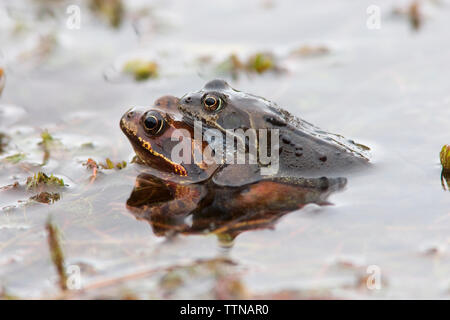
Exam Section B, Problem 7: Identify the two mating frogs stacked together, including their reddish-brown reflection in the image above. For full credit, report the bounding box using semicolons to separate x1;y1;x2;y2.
120;80;368;238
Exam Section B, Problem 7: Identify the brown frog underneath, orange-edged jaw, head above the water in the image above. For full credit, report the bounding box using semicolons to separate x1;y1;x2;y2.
120;96;220;181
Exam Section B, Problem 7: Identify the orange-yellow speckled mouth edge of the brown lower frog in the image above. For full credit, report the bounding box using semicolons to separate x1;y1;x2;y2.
120;118;187;176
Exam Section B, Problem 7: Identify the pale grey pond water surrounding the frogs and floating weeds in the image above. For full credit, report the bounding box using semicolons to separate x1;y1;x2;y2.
0;0;450;299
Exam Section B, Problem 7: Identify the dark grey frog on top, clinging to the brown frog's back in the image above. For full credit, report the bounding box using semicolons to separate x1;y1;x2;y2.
178;80;369;176
